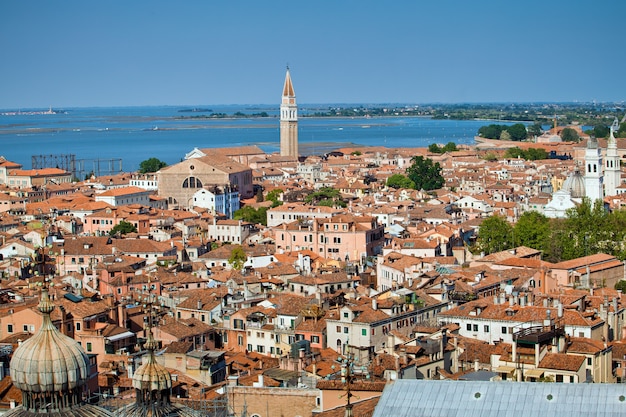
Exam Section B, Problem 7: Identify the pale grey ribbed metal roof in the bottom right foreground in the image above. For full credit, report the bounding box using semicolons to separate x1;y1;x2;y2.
373;379;626;417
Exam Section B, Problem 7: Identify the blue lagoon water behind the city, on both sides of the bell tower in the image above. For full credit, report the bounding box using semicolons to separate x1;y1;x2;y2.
0;106;488;172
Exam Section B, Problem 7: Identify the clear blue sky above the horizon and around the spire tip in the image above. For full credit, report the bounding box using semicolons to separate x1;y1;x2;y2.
0;0;626;109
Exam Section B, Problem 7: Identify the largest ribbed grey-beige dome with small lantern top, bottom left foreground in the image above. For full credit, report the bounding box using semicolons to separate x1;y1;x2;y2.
11;290;89;393
